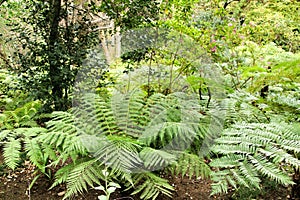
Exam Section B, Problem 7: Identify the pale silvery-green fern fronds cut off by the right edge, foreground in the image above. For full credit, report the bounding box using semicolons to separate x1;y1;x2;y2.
210;123;300;194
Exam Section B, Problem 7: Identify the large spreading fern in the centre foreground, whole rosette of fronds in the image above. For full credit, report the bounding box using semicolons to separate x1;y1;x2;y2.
39;91;210;199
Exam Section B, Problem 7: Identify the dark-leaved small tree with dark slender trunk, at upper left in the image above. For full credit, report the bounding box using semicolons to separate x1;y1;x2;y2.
3;1;95;111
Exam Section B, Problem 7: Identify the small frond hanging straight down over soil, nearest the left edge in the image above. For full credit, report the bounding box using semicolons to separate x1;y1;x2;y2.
3;137;21;170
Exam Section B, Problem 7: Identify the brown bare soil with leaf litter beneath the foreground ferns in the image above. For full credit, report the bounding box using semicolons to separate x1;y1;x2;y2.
0;153;300;200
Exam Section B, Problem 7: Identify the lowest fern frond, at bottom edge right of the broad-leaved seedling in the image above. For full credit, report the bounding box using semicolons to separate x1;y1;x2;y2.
132;173;174;200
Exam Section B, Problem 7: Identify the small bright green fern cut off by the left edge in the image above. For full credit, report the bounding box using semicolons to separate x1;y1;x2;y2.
0;101;46;169
